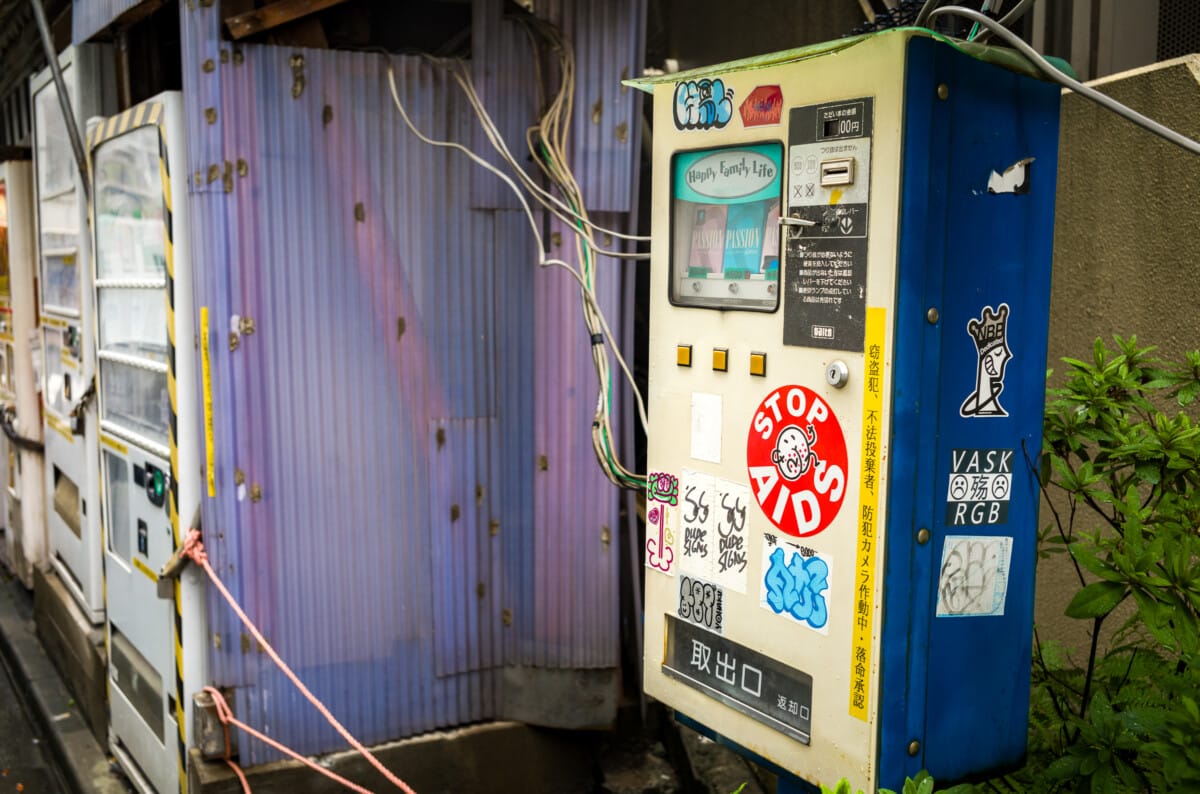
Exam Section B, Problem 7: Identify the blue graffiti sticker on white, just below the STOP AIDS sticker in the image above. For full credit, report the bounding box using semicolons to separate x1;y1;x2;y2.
758;534;833;634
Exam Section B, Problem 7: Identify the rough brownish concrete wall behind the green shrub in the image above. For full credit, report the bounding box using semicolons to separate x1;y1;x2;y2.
1033;55;1200;646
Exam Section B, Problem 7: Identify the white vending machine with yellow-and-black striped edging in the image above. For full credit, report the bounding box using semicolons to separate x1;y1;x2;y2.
88;92;204;794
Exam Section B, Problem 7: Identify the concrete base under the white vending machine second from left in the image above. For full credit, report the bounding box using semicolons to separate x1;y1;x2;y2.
34;571;108;747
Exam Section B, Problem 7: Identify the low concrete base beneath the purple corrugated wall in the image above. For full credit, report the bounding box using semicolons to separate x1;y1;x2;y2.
187;722;596;794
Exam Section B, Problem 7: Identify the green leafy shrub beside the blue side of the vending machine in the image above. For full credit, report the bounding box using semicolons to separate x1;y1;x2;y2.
977;337;1200;793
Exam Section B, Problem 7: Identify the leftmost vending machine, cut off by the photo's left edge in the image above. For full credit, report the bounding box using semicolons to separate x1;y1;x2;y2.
0;161;47;588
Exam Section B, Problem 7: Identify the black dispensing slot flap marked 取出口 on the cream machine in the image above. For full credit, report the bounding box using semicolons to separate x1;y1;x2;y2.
662;615;812;745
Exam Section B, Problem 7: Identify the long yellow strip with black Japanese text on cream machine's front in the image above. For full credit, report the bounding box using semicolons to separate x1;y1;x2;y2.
850;307;887;721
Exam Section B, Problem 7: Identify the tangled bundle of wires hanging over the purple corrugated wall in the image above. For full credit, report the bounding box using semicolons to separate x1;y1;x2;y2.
388;16;649;489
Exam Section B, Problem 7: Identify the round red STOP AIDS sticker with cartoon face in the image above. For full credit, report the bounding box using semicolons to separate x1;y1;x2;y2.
746;385;847;537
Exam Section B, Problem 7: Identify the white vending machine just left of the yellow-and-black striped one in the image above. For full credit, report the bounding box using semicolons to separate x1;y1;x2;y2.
30;44;116;624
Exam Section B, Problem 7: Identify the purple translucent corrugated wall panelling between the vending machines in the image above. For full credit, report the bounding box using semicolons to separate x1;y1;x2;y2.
181;0;636;764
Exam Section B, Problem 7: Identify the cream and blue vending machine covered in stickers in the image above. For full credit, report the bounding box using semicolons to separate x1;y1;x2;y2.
636;30;1060;792
